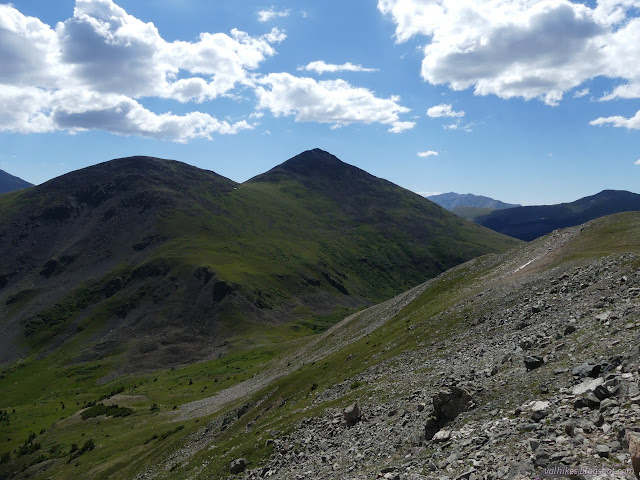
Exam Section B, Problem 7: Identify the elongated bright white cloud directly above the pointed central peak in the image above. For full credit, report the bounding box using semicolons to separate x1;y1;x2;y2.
256;73;415;133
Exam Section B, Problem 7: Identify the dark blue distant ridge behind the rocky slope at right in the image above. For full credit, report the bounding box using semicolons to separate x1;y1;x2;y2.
475;190;640;241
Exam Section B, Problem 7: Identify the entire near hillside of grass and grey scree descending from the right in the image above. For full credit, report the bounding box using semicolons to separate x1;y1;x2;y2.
139;213;640;480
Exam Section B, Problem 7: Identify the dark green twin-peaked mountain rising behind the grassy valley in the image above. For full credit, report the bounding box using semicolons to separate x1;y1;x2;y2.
0;149;519;370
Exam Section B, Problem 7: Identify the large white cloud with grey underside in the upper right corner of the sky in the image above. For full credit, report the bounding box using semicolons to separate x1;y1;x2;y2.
378;0;640;109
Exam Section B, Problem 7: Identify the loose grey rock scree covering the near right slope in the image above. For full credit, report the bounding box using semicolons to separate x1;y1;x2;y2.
230;223;640;480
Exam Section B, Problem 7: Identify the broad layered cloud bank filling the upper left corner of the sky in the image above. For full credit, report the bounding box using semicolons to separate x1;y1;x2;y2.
0;0;285;142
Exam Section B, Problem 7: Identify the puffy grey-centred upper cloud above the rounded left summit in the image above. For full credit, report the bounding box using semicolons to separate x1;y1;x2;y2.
57;0;285;102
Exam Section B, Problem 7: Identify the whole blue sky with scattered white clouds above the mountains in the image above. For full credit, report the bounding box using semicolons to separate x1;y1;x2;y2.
0;0;640;204
